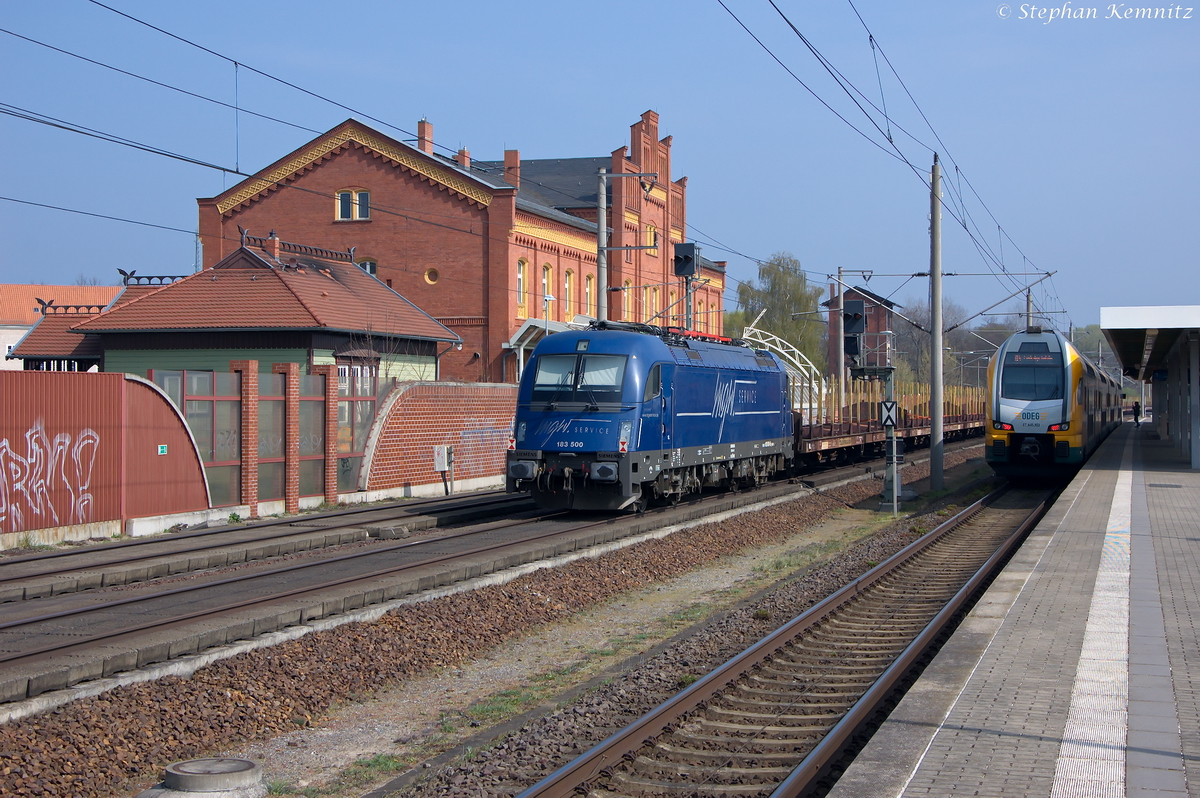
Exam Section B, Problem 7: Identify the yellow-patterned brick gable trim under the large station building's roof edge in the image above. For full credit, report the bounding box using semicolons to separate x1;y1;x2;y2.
200;119;506;214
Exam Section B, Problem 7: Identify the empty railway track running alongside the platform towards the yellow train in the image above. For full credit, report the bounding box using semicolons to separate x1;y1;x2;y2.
520;488;1050;798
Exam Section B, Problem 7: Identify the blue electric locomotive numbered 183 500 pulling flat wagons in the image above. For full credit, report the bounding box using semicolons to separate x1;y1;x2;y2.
506;322;793;510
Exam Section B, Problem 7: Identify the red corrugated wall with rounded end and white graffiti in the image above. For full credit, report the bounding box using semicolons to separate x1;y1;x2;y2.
0;371;209;533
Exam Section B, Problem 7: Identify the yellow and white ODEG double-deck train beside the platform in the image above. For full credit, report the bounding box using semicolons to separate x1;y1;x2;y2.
985;326;1121;476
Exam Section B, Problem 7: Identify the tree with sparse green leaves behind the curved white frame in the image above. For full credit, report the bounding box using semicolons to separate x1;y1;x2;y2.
725;252;826;370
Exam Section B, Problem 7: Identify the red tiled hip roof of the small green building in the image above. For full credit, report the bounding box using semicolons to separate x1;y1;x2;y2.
74;246;461;341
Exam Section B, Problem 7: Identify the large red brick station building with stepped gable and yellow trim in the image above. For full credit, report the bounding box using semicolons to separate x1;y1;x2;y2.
198;110;725;383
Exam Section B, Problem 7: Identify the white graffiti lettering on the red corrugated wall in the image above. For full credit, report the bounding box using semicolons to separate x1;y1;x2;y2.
0;419;100;532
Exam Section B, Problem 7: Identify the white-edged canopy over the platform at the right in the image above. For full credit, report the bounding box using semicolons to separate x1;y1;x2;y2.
1100;305;1200;380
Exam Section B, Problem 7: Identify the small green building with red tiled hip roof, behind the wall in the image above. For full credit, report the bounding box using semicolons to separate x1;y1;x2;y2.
71;236;461;379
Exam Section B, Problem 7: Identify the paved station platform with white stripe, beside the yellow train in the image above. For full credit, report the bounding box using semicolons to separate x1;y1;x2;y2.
829;424;1200;798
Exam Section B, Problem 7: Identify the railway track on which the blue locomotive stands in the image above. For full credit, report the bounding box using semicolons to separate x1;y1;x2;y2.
0;470;803;703
